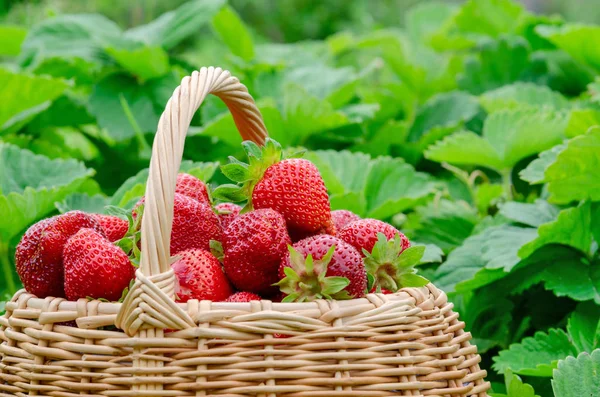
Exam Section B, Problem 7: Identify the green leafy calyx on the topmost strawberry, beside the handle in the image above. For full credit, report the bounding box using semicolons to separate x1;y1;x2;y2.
212;138;302;213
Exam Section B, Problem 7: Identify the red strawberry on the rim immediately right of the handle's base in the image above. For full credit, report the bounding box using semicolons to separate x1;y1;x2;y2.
171;249;233;302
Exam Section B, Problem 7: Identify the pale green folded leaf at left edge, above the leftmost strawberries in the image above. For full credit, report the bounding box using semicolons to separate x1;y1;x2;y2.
0;143;93;242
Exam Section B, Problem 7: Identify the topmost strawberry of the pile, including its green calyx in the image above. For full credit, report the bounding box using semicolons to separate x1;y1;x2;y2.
215;139;335;241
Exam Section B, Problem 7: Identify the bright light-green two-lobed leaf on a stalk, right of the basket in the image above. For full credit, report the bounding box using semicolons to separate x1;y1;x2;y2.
425;109;567;170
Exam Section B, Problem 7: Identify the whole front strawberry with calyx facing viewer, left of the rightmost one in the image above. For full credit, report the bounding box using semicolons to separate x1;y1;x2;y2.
277;235;367;302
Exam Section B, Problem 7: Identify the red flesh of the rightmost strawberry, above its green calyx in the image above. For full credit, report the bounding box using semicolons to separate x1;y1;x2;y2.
338;219;410;255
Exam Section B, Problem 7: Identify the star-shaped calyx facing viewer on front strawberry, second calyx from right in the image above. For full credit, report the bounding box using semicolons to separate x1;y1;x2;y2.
274;245;351;302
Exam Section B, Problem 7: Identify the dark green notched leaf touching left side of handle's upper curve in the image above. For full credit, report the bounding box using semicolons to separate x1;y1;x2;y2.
89;74;178;141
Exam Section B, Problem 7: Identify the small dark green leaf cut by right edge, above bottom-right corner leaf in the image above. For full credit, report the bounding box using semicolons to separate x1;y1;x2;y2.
567;302;600;352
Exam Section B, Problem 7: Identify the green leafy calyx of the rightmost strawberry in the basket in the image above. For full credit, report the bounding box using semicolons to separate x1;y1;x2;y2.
363;233;429;292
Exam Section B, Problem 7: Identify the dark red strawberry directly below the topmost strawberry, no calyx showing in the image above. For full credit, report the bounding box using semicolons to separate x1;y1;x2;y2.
223;209;291;296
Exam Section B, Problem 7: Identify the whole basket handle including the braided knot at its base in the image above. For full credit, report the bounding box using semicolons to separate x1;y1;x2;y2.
116;67;267;336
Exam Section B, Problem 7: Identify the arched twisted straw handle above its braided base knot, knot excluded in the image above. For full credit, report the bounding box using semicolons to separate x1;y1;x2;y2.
140;66;267;277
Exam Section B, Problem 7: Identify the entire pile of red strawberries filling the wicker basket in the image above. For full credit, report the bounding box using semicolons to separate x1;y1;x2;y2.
16;140;427;302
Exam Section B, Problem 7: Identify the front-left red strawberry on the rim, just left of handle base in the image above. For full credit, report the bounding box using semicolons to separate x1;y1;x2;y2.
63;229;135;301
